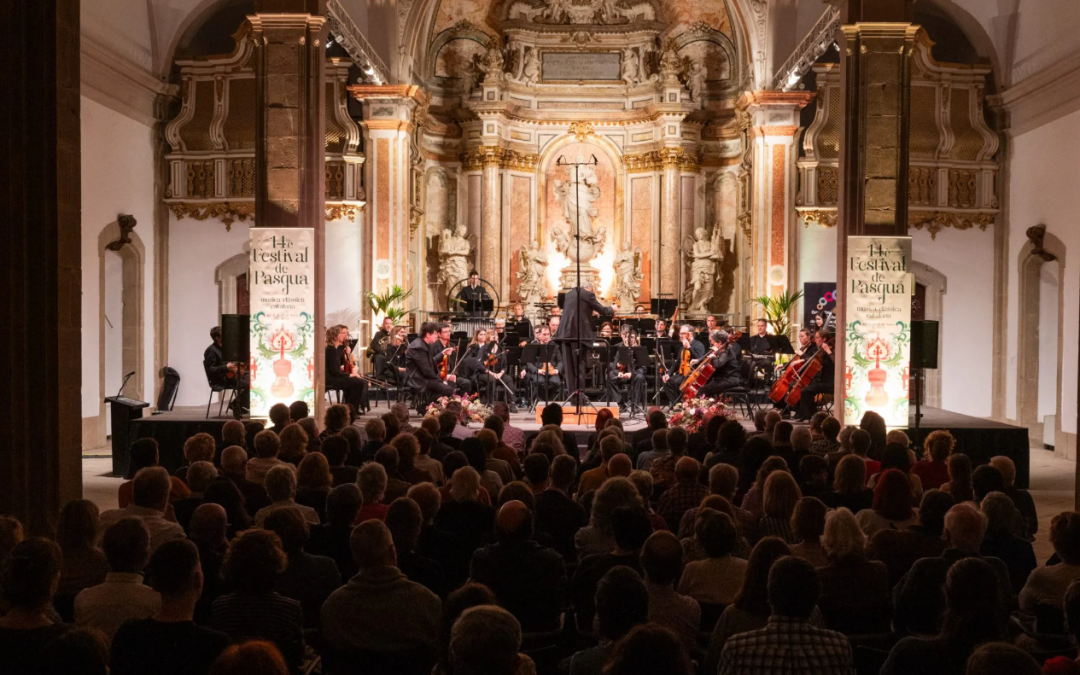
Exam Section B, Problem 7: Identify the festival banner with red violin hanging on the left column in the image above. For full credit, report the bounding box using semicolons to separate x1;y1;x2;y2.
248;228;315;417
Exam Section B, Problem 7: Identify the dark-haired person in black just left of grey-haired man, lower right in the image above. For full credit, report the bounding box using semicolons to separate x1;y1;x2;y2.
866;489;956;588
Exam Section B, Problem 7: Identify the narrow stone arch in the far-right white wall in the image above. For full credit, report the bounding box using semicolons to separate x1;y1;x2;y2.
1016;228;1067;440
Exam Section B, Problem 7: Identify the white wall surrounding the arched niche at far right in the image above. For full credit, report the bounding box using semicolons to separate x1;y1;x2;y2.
1005;112;1080;433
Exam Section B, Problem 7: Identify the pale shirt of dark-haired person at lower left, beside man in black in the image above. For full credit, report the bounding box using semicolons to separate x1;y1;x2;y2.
75;572;161;642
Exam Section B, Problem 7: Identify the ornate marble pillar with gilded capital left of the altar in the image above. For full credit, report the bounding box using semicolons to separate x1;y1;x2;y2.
349;84;428;292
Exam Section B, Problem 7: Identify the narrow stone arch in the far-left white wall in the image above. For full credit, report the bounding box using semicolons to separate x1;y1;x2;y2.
95;219;145;445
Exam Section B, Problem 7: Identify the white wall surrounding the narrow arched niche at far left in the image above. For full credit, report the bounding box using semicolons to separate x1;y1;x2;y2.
81;96;157;417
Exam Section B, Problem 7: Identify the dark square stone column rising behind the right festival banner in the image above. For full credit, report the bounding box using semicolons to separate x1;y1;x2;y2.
835;0;919;401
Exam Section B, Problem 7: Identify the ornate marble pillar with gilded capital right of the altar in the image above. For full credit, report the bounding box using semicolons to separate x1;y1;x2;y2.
737;91;813;297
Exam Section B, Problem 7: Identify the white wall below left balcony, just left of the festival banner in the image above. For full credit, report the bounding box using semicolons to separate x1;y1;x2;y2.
168;215;248;406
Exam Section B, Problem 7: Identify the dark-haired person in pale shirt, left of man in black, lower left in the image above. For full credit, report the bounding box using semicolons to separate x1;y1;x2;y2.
75;518;161;640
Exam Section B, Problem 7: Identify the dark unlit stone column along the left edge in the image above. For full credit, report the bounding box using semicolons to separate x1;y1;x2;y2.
0;0;83;535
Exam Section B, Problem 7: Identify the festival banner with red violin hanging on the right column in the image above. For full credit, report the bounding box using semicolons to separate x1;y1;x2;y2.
840;237;914;428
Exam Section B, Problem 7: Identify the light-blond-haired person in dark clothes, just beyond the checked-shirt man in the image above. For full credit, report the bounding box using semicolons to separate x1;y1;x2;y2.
818;508;889;635
